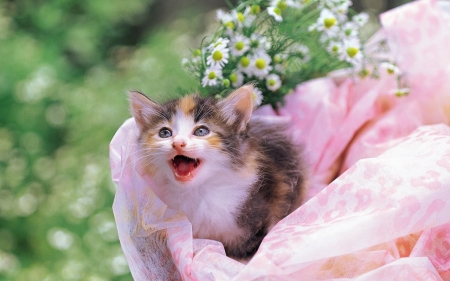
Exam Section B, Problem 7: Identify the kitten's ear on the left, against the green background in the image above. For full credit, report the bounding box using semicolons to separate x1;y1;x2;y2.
128;91;161;132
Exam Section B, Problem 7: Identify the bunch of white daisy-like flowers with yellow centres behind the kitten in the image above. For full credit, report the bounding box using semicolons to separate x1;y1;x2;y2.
183;0;408;107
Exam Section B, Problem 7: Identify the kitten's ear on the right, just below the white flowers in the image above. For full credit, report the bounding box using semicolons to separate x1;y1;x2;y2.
219;85;254;131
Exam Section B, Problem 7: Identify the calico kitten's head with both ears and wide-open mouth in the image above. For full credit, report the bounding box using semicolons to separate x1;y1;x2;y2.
130;86;253;185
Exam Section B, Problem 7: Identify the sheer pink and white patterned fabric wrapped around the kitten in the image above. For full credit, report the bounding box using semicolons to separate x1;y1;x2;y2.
110;0;450;280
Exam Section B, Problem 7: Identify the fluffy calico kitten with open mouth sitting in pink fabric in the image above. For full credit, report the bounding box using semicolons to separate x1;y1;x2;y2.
130;85;305;259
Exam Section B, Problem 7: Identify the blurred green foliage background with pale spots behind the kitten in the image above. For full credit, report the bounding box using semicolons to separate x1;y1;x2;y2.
0;0;414;281
